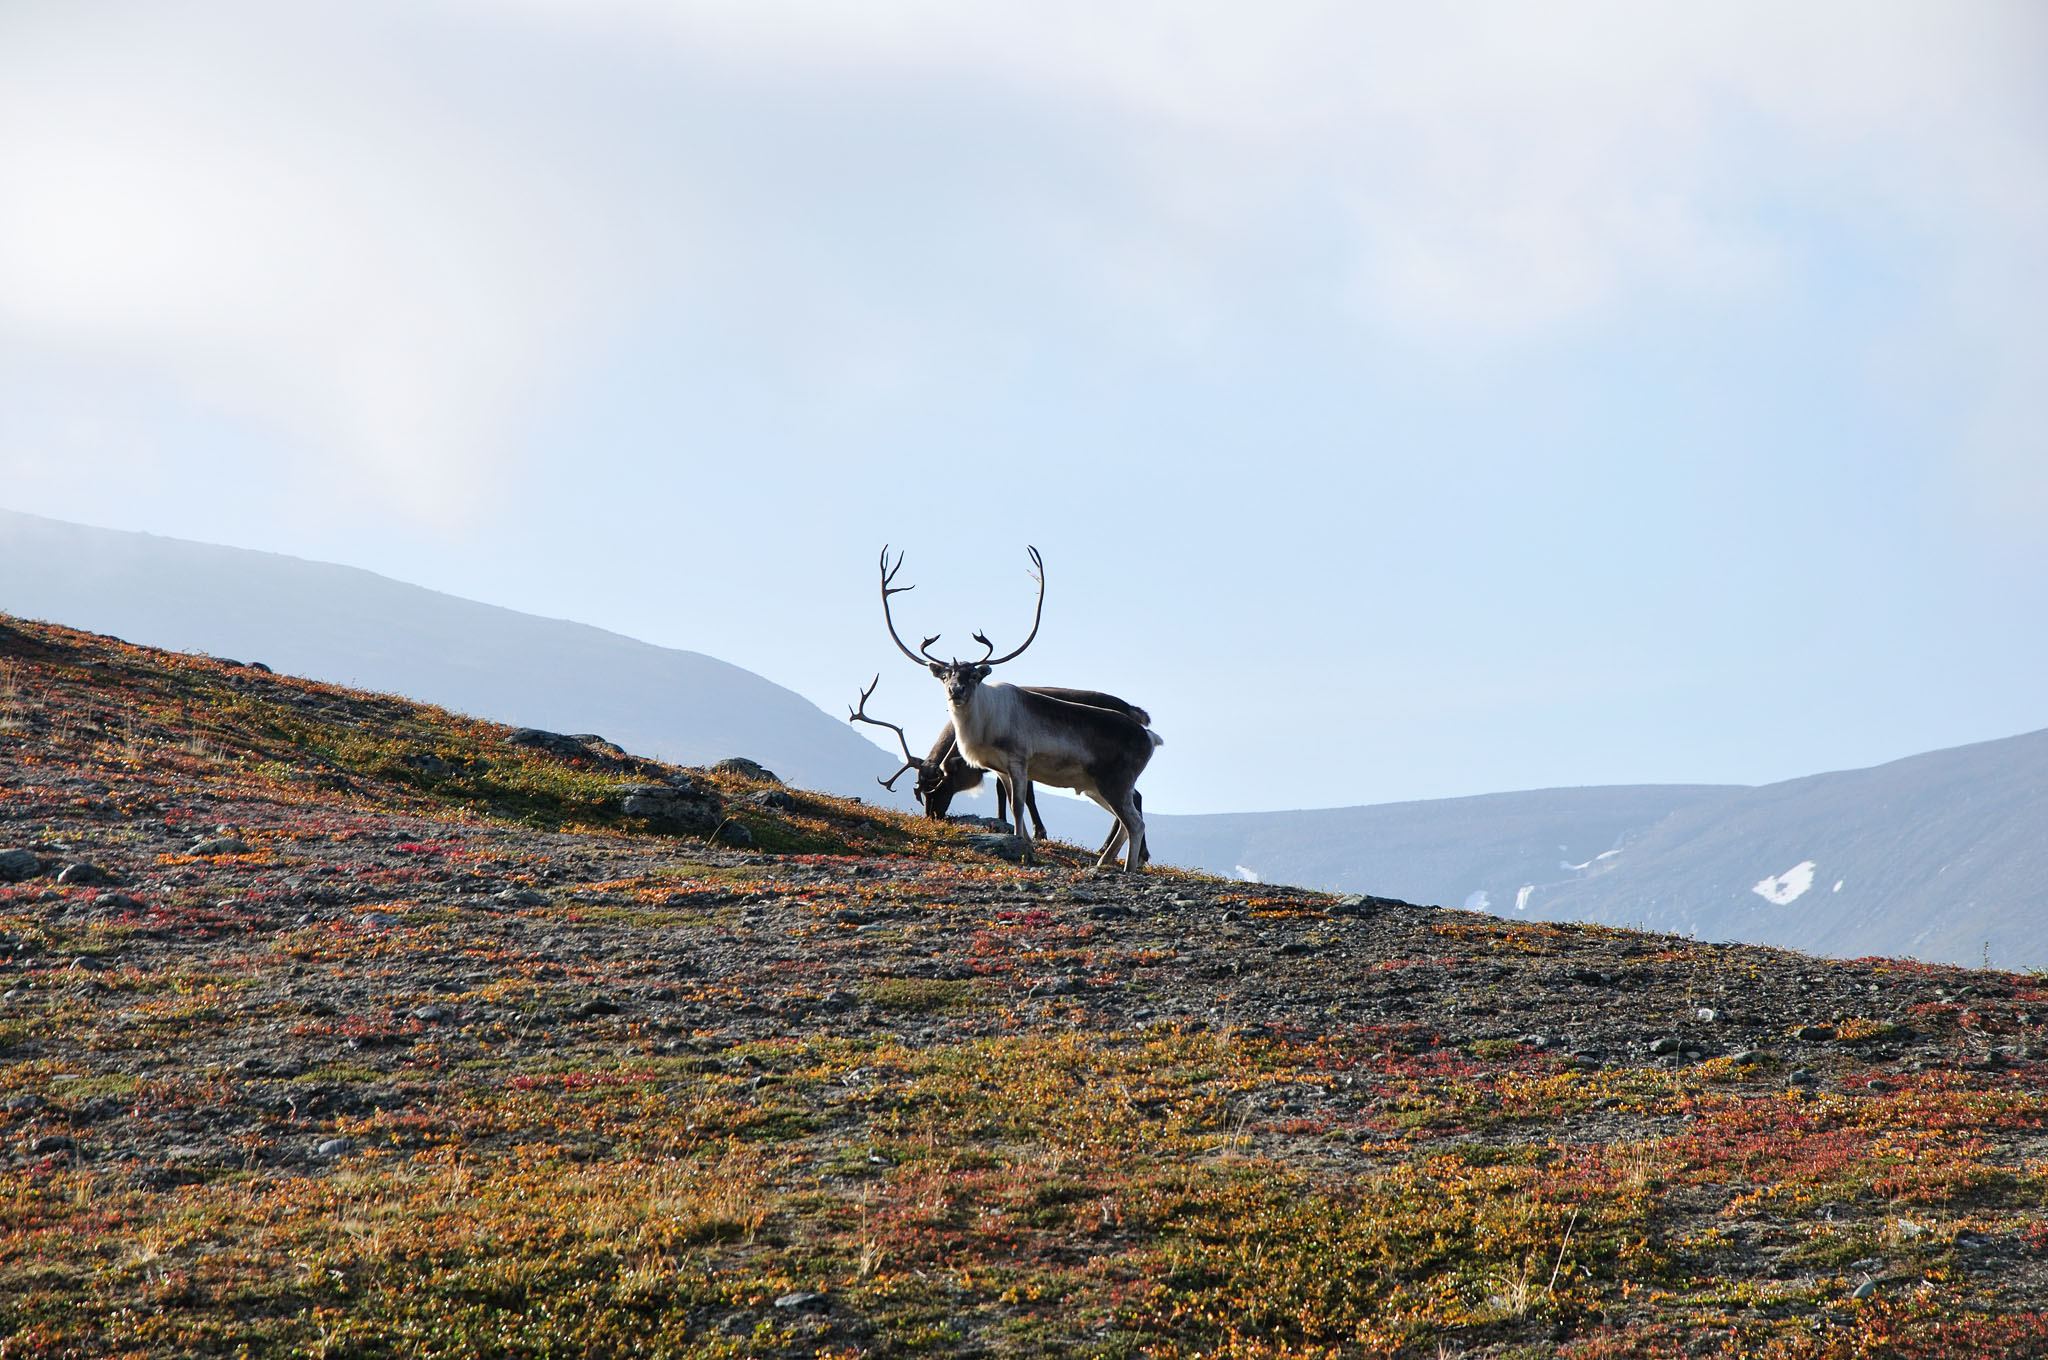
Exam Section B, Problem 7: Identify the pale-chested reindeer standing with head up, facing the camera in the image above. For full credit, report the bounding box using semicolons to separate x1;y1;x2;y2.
881;547;1161;873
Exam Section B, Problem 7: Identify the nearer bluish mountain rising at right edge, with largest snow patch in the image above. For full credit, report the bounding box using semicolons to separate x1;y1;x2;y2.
1528;731;2048;969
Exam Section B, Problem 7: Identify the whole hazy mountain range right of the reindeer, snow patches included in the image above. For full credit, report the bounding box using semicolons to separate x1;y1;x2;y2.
1105;731;2048;969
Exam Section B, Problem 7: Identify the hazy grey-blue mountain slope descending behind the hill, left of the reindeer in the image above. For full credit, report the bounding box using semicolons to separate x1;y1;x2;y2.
0;510;913;801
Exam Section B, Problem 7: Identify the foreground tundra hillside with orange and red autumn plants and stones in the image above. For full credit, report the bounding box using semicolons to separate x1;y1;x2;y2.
0;621;2048;1360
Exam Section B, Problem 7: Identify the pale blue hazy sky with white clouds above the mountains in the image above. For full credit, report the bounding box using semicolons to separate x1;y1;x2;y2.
0;0;2048;811
